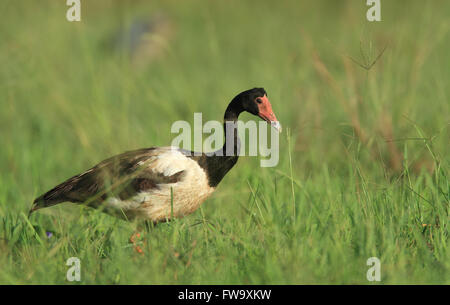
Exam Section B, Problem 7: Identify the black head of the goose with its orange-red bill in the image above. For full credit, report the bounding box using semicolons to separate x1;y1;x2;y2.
225;88;281;131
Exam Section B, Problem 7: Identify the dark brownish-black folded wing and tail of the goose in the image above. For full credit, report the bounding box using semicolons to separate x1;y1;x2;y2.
30;148;184;213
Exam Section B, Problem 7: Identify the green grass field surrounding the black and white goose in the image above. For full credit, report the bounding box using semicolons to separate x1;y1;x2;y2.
0;0;450;284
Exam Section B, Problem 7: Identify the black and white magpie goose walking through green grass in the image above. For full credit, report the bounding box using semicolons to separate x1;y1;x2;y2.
30;88;281;224
